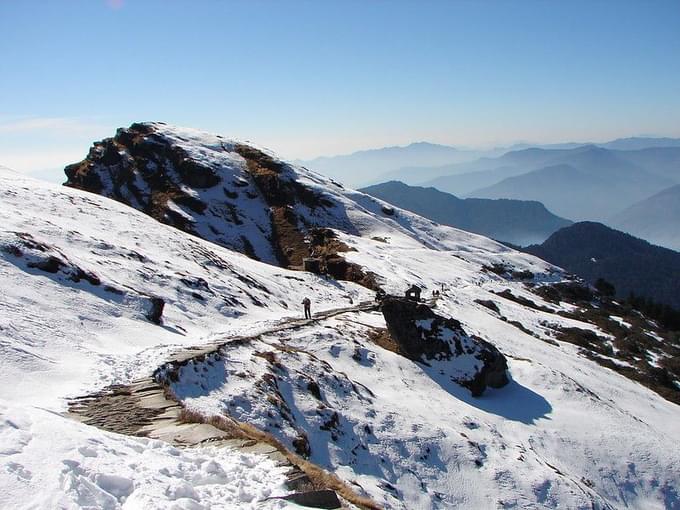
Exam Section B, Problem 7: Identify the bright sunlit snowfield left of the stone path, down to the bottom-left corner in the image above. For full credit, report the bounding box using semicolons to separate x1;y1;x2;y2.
0;171;369;508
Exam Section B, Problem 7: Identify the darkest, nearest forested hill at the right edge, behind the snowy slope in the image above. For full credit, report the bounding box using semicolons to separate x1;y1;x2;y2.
524;222;680;309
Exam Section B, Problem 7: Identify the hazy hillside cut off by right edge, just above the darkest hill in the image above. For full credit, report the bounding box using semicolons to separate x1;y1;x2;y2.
608;184;680;251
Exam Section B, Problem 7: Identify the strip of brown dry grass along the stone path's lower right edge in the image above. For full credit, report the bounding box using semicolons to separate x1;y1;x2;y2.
179;409;381;510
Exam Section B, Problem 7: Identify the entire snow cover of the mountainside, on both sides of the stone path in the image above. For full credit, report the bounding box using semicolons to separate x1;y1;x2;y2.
0;125;680;509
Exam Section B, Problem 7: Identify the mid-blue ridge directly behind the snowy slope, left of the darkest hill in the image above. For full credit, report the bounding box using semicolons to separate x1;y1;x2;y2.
361;181;571;245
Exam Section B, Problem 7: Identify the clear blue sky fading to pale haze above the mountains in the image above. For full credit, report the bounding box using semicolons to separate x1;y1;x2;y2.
0;0;680;179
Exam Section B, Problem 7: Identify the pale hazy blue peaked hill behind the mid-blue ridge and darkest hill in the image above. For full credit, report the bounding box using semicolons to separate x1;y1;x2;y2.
469;146;674;221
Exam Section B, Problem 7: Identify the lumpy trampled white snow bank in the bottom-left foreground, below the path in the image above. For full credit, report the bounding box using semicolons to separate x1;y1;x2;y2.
0;402;287;510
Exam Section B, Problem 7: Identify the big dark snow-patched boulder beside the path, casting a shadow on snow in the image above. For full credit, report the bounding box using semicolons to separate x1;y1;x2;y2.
381;297;508;396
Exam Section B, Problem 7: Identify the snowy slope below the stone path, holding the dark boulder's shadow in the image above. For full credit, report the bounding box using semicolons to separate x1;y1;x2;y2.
173;313;680;508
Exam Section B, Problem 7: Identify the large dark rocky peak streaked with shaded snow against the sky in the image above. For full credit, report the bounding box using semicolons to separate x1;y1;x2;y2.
65;123;376;288
